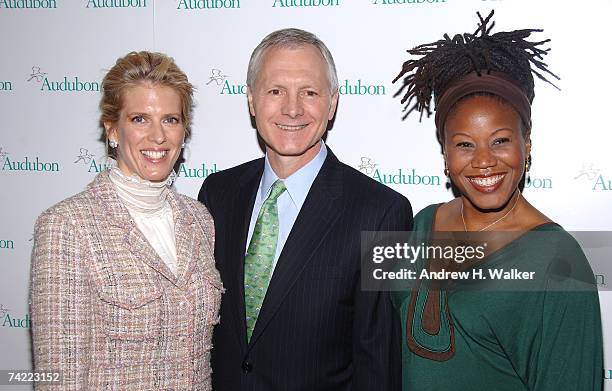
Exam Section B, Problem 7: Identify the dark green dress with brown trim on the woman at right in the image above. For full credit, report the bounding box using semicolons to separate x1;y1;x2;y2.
393;205;603;391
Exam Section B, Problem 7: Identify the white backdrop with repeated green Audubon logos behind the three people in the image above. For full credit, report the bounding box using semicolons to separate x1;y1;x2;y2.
0;0;612;390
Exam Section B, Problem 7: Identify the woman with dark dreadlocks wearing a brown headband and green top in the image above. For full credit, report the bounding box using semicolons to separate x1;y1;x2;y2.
394;12;603;391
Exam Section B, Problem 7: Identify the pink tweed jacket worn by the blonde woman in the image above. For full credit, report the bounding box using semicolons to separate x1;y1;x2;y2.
31;172;223;391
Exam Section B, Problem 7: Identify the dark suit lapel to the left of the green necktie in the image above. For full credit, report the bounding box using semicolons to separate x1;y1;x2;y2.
226;159;264;351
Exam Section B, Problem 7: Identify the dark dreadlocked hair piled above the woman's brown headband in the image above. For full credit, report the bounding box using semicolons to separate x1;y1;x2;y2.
393;10;559;120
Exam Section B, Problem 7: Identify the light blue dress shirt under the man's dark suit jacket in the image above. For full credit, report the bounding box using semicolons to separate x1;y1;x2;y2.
244;140;327;272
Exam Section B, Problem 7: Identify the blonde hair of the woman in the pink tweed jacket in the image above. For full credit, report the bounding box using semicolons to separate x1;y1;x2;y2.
98;51;195;159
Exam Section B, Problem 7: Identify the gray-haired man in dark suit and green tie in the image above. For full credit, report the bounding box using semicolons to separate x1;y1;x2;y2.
198;29;412;391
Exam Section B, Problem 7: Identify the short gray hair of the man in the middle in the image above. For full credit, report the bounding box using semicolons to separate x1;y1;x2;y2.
247;28;338;95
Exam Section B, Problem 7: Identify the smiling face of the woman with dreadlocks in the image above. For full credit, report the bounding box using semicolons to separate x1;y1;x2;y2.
444;95;531;211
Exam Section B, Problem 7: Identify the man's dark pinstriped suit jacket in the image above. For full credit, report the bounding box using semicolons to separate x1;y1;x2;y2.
198;150;412;391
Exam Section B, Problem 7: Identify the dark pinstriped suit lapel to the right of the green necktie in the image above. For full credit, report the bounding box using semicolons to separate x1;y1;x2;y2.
249;150;343;346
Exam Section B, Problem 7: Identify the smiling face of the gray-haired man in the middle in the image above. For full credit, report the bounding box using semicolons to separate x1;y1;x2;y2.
247;45;338;166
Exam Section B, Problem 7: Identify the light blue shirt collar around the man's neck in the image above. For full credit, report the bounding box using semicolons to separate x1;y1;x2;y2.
259;140;327;209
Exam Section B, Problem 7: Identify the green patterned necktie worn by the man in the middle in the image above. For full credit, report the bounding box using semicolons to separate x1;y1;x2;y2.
244;179;287;341
